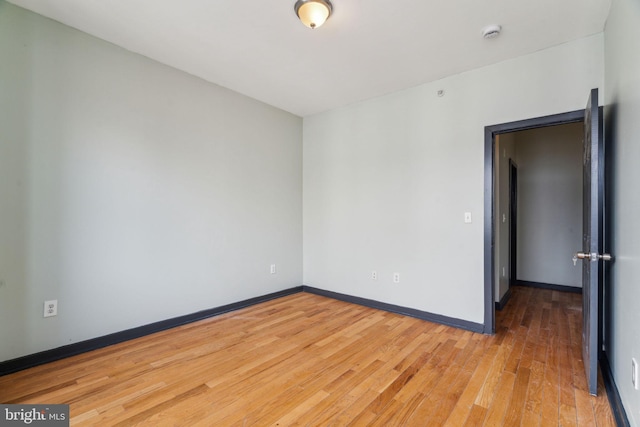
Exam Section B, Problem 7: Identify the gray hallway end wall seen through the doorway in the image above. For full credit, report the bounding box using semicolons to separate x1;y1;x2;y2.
515;124;586;287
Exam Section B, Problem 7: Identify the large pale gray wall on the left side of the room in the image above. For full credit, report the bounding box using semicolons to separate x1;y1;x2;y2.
0;1;302;361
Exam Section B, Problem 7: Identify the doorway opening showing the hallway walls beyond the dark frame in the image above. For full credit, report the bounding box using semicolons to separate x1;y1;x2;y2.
494;122;584;309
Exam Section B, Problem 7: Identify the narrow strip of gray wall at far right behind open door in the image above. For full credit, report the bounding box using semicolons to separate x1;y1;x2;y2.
605;0;640;426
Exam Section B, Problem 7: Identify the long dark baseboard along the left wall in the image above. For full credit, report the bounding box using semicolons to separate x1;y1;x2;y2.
0;286;302;376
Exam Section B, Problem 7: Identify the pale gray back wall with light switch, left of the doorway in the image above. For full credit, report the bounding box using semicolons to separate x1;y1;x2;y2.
303;34;604;323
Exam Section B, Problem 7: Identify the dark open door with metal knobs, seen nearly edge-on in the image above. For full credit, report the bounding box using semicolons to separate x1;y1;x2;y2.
574;89;611;395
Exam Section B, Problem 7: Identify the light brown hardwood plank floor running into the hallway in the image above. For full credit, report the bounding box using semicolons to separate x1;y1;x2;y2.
0;287;615;426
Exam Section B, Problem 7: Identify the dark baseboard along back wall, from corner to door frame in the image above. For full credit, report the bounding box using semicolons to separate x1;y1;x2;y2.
302;286;484;333
